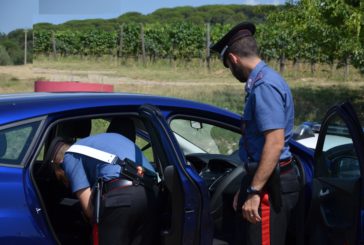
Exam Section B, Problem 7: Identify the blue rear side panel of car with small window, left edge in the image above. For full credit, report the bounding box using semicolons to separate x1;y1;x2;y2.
0;118;55;244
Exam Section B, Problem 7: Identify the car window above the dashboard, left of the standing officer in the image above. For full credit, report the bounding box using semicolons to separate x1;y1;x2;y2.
170;118;241;155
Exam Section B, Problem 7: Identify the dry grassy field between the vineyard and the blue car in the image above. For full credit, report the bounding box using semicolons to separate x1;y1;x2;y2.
0;56;364;124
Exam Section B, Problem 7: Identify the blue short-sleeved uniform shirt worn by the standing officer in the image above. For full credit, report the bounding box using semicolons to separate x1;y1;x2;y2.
239;61;294;162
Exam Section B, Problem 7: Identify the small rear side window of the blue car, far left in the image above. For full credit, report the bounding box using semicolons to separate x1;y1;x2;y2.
0;122;40;165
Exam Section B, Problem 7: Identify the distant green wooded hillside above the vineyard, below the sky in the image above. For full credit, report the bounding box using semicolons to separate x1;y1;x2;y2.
34;5;284;31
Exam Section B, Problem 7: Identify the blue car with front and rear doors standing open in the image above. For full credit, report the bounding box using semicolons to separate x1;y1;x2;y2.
0;93;364;245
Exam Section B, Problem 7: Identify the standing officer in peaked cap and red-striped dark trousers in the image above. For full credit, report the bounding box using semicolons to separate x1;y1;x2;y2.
211;22;300;245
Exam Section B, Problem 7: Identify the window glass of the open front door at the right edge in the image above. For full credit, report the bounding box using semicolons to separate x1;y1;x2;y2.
322;114;360;178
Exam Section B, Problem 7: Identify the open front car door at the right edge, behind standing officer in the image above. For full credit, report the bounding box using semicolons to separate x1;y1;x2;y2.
308;103;364;245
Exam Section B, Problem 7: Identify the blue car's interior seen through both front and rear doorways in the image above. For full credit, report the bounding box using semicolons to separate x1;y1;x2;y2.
32;115;250;244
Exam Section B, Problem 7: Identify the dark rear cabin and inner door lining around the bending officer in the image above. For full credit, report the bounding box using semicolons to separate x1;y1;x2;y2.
32;115;188;244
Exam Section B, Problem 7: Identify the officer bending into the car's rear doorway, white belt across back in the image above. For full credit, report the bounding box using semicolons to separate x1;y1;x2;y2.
49;133;158;245
